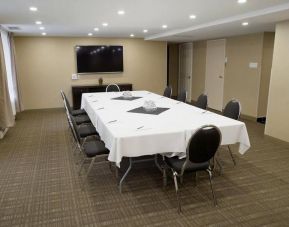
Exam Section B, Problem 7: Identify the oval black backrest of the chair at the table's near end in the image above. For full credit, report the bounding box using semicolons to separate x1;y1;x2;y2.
187;125;222;163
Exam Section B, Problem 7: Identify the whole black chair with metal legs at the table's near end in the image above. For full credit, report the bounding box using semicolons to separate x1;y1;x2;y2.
163;125;222;212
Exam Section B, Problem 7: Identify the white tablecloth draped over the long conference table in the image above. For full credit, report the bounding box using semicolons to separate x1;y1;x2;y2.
81;91;250;166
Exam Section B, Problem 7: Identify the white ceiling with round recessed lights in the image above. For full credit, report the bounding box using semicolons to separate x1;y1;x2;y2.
0;0;289;42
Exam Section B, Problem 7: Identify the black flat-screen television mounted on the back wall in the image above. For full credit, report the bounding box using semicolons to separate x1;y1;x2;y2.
75;45;123;73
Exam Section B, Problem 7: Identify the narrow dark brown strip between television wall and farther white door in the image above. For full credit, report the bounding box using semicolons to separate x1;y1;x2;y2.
168;44;179;96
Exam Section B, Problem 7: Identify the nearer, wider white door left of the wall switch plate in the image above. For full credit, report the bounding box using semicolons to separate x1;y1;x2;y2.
205;39;226;111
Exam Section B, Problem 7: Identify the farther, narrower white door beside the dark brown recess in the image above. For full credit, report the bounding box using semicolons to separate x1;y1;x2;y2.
178;43;193;102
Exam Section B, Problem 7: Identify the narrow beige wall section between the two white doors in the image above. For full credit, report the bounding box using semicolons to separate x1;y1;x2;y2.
192;41;207;101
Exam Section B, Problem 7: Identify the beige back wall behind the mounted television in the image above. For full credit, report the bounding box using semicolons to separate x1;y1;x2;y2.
15;37;167;109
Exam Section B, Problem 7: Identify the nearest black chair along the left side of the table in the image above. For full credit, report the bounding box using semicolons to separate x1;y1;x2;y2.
70;115;109;177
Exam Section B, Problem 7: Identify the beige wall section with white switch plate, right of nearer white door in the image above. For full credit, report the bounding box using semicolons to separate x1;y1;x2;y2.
224;33;263;117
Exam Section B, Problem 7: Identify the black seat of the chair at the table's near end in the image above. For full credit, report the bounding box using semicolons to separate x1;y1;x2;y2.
165;157;210;173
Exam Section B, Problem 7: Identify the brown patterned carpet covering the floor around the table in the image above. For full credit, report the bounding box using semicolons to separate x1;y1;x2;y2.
0;109;289;227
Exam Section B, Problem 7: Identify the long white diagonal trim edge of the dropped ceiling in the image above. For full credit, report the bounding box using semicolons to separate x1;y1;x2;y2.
145;3;289;40
